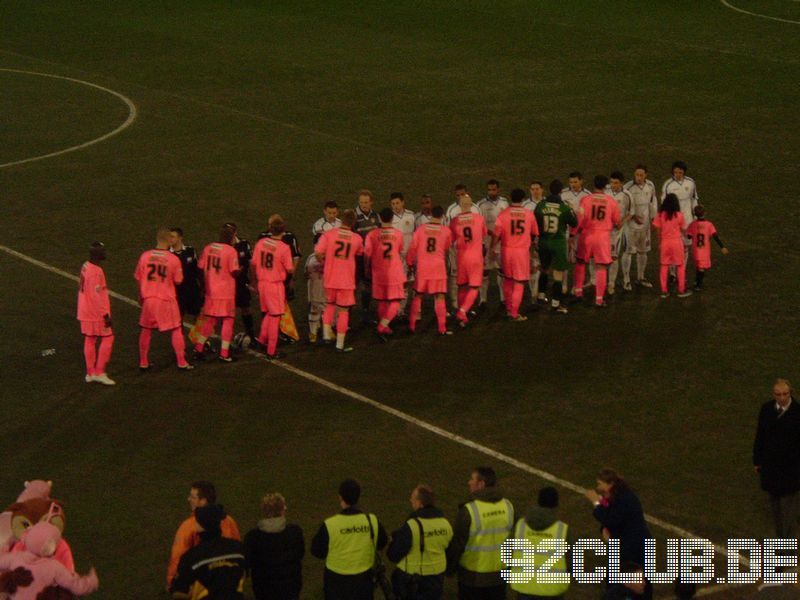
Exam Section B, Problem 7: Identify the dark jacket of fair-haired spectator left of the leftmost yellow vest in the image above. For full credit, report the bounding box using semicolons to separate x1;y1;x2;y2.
244;517;306;600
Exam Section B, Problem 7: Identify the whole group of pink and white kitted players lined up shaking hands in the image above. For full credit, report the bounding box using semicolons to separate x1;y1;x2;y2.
73;161;728;385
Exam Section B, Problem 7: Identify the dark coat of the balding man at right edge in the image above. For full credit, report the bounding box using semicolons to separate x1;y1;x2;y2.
753;398;800;496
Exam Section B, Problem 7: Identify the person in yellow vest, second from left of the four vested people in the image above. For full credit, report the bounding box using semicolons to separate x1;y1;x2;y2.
386;485;453;600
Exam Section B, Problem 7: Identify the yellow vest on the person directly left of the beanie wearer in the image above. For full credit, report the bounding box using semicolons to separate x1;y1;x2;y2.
459;498;514;573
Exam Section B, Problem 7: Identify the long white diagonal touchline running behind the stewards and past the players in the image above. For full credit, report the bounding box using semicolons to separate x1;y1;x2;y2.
0;245;749;595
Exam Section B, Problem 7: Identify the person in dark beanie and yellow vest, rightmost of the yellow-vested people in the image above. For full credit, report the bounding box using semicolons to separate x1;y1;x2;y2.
510;487;575;600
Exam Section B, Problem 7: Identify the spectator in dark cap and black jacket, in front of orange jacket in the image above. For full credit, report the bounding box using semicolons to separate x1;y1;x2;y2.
170;504;247;600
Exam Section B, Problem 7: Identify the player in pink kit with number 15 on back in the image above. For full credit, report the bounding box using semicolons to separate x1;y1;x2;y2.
492;188;539;321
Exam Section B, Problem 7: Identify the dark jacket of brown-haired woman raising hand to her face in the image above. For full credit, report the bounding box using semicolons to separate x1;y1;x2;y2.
593;490;652;565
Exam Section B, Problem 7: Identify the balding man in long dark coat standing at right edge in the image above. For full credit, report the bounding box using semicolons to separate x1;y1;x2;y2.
753;379;800;538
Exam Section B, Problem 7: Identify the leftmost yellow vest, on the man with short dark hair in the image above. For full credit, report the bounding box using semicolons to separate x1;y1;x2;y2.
325;513;378;575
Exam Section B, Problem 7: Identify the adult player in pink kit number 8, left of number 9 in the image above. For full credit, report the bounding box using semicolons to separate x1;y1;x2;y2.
406;206;453;335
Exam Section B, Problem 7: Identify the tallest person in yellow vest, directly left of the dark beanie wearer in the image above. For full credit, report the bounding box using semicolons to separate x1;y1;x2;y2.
447;467;515;600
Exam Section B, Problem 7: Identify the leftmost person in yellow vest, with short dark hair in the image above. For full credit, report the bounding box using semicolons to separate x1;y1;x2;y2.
311;479;387;600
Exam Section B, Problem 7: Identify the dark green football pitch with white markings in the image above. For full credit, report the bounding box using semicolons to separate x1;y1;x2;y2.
0;0;800;598
